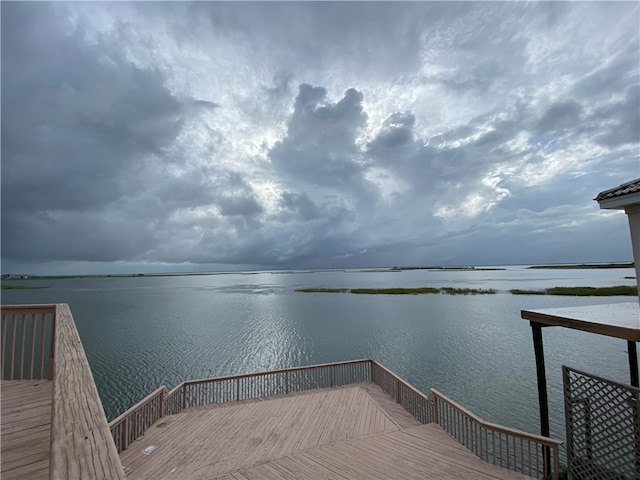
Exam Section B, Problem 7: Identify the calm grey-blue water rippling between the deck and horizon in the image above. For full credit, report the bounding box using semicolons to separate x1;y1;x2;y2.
2;267;635;446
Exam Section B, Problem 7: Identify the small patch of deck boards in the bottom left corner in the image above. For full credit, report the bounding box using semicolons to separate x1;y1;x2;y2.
0;380;53;480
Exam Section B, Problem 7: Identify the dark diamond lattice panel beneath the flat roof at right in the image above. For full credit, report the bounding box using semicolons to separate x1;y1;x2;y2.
562;366;640;480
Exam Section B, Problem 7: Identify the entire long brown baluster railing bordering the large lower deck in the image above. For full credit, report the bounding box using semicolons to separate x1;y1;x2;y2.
109;360;561;479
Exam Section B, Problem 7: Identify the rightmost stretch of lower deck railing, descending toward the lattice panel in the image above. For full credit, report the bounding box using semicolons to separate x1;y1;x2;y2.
431;390;562;480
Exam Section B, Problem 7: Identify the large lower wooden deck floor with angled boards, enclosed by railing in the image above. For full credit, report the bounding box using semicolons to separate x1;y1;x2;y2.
120;383;529;480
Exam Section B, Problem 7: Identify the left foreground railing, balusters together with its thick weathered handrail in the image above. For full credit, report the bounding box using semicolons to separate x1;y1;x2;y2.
0;304;125;480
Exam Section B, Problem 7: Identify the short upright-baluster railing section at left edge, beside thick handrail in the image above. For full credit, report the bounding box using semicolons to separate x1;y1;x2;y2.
0;305;56;380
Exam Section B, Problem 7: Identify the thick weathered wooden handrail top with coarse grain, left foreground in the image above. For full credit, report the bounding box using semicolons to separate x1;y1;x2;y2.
50;304;125;480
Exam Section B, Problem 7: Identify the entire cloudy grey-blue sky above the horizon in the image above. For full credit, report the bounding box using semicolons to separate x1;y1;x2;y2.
0;1;640;275
